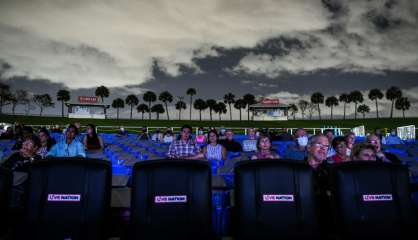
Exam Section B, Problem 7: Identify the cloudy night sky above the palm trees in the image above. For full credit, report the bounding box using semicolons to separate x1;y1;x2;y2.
0;0;418;119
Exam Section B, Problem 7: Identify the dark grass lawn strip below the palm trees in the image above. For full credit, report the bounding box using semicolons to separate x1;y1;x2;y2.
0;114;418;131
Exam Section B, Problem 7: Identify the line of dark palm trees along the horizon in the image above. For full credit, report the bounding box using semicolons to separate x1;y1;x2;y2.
0;82;411;121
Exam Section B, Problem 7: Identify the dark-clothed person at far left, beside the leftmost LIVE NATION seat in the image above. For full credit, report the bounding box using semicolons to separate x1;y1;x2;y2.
0;136;42;209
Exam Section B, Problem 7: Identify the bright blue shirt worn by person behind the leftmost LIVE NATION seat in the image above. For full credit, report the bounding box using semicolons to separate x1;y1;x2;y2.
46;139;86;157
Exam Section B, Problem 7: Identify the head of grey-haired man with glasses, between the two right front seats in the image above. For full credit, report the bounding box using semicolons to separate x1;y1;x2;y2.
307;135;329;169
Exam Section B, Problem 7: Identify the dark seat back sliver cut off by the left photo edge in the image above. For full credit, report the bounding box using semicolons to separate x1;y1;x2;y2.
0;168;13;237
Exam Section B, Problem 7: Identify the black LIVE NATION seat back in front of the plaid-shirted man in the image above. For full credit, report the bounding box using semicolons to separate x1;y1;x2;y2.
130;159;212;239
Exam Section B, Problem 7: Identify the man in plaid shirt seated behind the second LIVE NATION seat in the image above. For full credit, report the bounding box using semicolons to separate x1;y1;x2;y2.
167;125;200;159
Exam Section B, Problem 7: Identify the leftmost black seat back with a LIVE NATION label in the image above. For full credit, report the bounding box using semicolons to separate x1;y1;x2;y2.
27;158;111;239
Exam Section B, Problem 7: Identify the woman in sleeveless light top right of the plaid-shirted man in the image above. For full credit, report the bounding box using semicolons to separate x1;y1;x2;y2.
196;130;227;161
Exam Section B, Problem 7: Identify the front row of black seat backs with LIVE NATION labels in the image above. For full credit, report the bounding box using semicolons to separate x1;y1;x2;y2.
0;159;417;239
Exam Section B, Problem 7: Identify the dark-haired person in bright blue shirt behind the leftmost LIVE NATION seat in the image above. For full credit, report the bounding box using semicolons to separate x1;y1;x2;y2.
46;124;86;157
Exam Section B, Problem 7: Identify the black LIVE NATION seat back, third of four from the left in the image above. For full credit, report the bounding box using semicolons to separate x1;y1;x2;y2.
234;160;319;239
